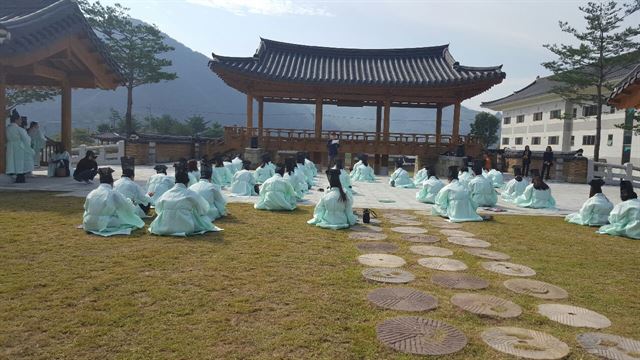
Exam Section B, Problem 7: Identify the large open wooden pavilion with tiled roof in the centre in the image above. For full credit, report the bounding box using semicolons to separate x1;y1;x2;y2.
209;39;505;169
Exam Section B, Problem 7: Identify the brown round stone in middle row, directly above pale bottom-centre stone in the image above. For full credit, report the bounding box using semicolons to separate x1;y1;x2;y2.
451;294;522;318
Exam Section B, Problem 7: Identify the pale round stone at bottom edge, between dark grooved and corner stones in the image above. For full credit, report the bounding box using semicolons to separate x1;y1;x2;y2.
480;327;570;359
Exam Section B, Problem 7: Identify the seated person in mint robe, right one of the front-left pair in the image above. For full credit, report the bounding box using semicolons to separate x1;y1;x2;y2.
149;163;222;236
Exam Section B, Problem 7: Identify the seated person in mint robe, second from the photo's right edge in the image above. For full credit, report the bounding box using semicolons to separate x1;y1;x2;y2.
564;178;613;226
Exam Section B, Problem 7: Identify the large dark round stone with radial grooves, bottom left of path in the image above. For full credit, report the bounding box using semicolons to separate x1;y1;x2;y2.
376;317;467;355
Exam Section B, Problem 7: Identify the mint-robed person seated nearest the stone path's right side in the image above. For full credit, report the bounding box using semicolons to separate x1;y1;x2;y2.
431;166;482;222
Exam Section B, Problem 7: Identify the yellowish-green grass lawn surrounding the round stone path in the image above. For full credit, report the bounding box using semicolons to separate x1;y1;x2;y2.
0;192;640;359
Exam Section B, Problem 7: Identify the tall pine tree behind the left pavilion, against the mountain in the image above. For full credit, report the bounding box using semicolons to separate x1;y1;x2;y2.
79;0;178;134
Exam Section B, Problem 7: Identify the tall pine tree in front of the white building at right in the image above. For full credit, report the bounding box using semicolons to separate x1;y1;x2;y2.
542;1;640;161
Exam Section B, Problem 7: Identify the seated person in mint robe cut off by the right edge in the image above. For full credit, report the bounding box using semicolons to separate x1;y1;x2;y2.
598;180;640;240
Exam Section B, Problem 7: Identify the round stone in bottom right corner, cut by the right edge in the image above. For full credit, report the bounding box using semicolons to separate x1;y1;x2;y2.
576;332;640;360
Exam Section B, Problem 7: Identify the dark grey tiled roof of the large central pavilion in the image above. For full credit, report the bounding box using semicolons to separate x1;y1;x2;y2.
209;39;505;86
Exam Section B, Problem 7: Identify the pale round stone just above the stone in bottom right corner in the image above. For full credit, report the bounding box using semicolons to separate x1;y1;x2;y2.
538;304;611;329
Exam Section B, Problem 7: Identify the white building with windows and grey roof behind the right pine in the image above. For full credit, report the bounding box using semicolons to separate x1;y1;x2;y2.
482;68;640;166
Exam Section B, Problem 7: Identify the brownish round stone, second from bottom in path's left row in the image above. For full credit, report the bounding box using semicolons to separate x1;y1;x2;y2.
367;287;438;311
